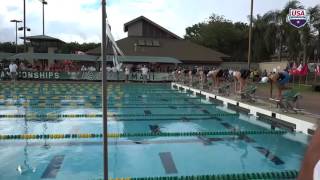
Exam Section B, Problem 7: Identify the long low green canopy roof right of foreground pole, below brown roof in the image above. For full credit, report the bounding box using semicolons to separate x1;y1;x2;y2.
98;56;181;64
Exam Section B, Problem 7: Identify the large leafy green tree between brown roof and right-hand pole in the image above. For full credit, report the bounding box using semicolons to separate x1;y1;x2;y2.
184;14;248;61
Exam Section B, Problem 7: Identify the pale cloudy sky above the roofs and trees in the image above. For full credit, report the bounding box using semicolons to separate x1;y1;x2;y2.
0;0;320;43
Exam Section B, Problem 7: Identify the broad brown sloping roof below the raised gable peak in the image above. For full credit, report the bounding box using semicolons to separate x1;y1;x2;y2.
87;37;229;63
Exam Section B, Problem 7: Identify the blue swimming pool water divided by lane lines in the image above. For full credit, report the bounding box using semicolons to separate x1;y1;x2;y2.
0;83;308;179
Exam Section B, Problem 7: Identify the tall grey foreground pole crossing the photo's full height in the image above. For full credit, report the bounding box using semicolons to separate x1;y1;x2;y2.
101;0;109;180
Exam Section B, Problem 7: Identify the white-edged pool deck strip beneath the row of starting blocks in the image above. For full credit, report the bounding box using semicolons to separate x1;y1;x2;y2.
171;83;320;135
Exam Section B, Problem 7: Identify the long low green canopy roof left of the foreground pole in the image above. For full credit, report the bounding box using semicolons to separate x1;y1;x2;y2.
8;53;98;61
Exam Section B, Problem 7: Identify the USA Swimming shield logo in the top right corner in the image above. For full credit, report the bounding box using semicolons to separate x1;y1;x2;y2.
287;9;309;28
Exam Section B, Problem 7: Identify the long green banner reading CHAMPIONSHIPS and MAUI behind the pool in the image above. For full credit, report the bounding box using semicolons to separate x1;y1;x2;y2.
0;71;173;81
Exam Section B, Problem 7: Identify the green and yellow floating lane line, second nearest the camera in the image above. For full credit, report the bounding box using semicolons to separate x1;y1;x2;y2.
0;130;287;140
